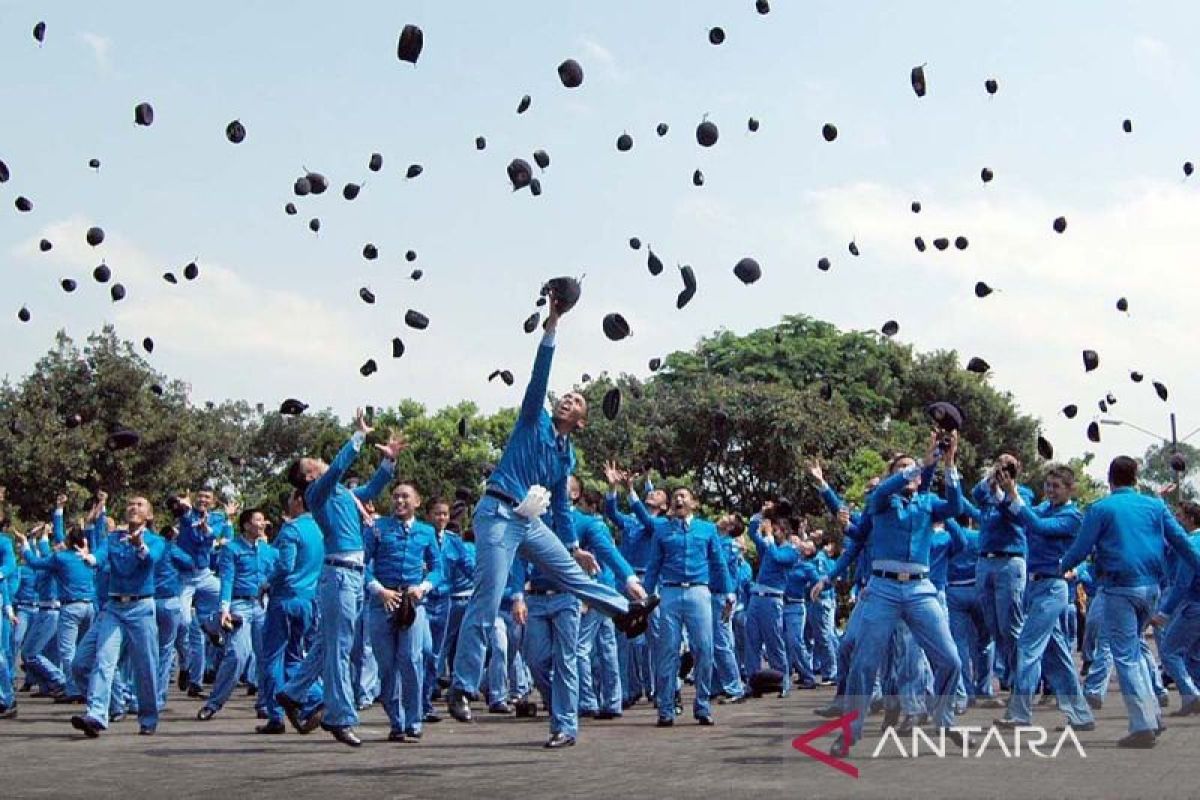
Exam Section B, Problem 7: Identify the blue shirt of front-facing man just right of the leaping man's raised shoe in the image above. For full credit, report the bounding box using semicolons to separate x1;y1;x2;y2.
646;517;734;595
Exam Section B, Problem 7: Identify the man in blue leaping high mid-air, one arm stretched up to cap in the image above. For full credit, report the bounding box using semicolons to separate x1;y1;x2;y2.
448;291;644;722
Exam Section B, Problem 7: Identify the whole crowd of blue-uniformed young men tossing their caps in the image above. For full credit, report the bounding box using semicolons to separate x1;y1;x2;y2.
0;293;1200;756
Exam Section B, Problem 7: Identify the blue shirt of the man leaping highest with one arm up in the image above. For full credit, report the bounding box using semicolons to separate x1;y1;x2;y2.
487;333;577;548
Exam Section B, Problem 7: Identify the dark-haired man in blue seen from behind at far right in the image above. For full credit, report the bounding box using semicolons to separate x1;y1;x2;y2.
1060;456;1200;748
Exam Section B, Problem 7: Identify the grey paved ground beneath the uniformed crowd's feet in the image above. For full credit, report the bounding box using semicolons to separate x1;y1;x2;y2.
0;690;1200;800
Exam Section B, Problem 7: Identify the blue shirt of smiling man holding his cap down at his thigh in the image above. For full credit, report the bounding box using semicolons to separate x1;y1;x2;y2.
364;517;442;593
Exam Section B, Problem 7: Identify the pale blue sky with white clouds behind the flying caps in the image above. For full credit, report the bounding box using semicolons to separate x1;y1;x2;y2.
0;0;1200;482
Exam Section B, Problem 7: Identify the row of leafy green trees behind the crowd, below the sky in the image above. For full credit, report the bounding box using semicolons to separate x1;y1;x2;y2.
0;315;1198;532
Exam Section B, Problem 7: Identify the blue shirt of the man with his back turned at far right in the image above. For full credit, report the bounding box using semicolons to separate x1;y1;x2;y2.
1060;487;1200;587
